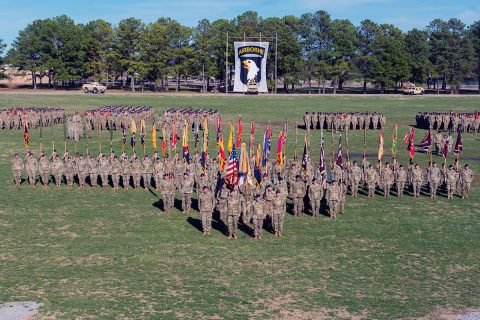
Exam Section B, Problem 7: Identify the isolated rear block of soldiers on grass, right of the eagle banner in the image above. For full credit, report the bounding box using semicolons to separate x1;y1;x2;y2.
303;112;387;132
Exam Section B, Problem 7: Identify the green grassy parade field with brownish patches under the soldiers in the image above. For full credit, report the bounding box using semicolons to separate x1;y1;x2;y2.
0;94;480;319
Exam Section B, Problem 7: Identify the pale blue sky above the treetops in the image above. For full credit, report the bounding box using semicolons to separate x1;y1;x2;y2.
0;0;480;44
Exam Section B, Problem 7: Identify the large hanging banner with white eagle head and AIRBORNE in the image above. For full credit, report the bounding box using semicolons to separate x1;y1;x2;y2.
233;42;269;92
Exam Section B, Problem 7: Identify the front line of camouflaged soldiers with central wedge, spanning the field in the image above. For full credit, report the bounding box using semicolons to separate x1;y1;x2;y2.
12;145;474;239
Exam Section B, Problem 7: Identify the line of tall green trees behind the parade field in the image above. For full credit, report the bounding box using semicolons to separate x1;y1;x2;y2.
0;11;480;93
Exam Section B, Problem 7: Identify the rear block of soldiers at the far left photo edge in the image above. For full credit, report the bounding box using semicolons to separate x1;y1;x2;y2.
0;108;65;130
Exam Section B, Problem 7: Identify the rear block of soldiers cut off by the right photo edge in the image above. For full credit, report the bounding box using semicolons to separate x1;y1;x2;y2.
415;111;480;132
